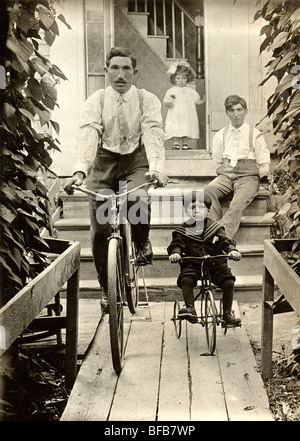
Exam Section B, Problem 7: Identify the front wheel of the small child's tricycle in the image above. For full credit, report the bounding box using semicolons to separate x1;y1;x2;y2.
204;289;217;354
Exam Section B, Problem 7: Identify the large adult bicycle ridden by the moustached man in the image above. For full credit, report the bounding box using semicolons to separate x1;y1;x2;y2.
72;181;157;374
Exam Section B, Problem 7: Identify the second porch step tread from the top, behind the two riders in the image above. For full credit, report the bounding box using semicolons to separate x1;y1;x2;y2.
54;216;274;230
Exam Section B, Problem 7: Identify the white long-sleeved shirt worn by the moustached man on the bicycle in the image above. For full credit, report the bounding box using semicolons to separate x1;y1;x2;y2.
73;86;165;175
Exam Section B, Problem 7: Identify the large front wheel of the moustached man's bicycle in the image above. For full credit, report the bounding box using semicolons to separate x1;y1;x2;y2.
107;238;125;374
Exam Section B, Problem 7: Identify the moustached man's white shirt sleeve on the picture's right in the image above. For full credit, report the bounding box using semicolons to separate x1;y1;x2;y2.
141;90;165;173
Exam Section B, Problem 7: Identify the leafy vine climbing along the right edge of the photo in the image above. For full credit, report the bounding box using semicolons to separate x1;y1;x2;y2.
255;0;300;251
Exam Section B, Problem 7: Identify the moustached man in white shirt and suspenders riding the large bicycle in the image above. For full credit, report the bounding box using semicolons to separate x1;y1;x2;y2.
64;47;166;302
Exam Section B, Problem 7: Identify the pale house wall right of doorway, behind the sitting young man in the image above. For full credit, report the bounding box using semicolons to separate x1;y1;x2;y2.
204;0;274;150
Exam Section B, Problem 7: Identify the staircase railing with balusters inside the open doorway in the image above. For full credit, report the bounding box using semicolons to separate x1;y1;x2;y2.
128;0;204;78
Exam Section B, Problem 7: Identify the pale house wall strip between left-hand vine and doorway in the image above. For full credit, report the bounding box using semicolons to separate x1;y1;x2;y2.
50;0;86;176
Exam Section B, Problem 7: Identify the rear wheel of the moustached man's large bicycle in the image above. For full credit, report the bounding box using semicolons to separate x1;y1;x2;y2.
122;221;139;314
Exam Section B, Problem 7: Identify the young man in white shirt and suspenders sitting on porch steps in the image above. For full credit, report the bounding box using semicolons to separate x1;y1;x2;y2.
204;95;270;239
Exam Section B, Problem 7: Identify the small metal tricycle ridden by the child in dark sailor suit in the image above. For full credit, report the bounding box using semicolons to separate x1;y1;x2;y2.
171;254;241;355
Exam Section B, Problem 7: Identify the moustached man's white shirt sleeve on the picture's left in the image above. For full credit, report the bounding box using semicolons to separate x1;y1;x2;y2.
73;89;103;176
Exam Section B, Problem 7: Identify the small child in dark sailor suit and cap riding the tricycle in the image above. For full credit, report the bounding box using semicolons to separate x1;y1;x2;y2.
167;192;241;326
